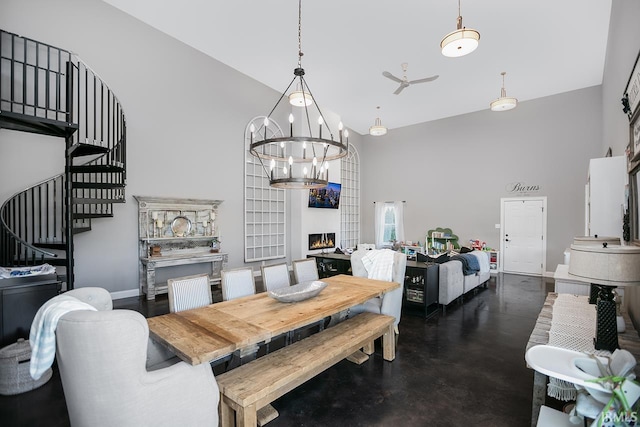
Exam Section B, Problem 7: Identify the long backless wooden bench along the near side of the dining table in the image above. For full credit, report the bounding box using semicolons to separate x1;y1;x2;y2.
216;313;395;427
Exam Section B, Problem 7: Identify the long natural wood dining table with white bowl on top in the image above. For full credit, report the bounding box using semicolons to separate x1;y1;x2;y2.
147;274;399;365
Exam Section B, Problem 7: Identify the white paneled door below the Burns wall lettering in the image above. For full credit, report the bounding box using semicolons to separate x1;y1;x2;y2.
500;197;547;275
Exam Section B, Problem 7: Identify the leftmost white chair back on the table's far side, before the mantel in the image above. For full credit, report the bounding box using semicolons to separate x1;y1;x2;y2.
167;274;213;313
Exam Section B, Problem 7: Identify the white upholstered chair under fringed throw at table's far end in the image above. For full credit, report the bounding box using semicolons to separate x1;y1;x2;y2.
350;250;407;333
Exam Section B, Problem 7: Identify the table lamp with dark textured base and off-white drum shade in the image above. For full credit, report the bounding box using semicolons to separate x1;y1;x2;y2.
569;242;640;352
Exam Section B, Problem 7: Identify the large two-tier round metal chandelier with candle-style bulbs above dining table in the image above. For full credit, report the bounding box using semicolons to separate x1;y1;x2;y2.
249;0;349;189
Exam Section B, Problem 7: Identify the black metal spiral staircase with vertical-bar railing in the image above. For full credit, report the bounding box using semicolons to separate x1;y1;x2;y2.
0;30;126;290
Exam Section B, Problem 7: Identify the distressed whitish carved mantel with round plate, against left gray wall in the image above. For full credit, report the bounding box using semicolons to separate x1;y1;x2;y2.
134;196;228;300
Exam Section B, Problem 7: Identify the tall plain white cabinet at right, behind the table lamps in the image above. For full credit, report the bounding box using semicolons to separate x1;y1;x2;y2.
585;156;627;237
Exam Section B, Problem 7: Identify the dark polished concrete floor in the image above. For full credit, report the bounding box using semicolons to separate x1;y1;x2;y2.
0;274;553;427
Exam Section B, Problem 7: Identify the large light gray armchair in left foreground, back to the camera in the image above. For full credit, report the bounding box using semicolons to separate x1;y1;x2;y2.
56;288;220;427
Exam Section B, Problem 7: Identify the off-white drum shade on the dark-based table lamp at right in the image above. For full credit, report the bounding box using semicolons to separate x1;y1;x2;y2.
569;244;640;286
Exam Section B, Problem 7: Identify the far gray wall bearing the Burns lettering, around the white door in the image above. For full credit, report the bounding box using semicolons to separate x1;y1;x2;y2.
362;86;605;271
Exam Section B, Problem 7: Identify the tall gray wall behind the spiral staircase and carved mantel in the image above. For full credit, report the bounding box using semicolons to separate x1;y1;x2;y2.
0;0;279;292
